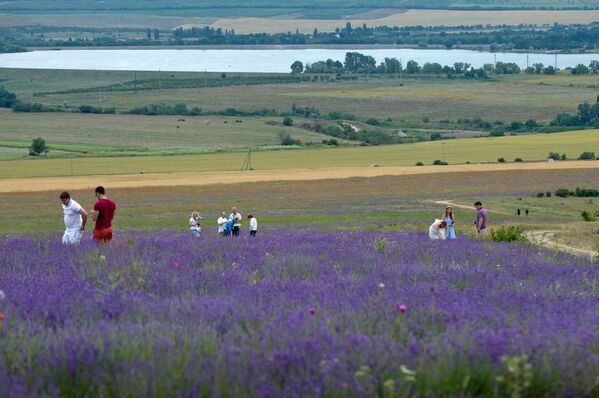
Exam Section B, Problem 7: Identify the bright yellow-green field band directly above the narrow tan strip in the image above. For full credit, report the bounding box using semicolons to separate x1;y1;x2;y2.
0;130;599;178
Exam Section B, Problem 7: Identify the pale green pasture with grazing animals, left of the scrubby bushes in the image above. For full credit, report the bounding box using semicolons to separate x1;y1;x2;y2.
0;109;346;159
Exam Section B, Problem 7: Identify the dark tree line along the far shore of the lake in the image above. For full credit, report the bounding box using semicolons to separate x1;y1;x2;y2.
0;22;599;52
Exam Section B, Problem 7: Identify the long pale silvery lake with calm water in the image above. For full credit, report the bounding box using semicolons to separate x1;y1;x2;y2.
0;49;599;72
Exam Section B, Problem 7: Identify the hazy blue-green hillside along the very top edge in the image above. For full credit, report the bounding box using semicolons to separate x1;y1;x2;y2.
0;0;599;18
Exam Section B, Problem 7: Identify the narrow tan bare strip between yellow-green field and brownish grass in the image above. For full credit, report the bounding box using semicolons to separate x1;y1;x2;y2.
0;161;599;193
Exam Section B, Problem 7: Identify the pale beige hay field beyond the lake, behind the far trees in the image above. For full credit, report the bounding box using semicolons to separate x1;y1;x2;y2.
204;10;599;34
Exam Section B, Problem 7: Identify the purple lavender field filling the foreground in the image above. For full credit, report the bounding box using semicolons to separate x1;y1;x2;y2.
0;229;599;397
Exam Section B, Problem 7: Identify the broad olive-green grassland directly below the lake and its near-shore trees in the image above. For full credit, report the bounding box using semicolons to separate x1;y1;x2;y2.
0;69;599;131
